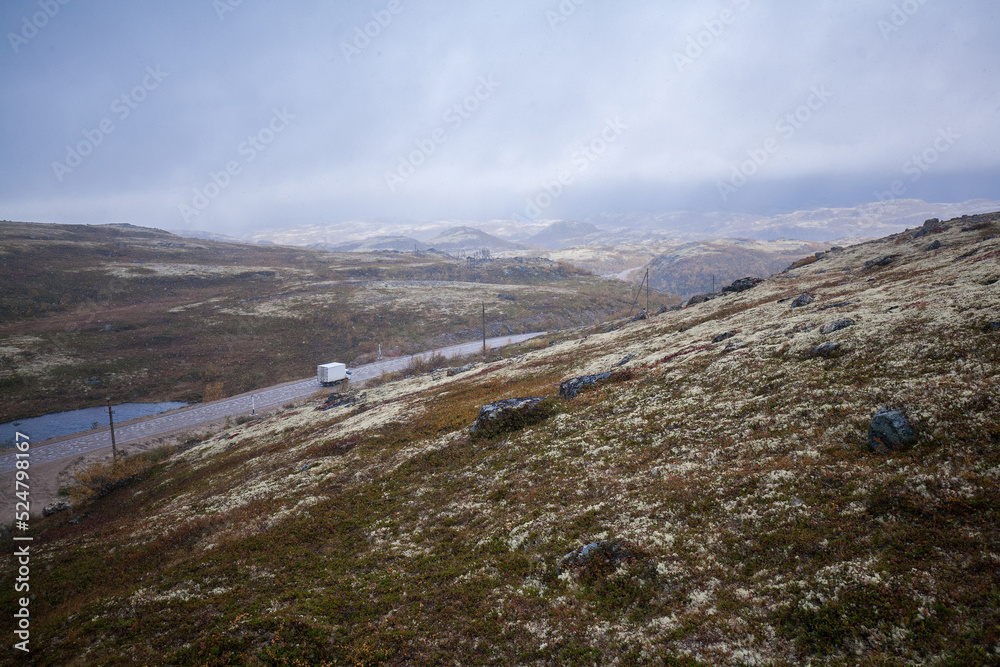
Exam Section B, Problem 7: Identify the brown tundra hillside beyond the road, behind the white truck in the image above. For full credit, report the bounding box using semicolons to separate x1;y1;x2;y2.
0;222;634;422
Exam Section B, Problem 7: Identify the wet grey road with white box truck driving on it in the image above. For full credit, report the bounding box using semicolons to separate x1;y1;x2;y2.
0;331;546;474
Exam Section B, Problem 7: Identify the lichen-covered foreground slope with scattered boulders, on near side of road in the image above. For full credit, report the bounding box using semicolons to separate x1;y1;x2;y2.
2;215;1000;665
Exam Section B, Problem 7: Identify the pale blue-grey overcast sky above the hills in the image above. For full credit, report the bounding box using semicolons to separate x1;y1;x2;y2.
0;0;1000;233
